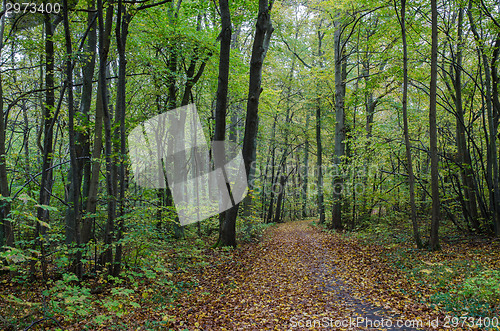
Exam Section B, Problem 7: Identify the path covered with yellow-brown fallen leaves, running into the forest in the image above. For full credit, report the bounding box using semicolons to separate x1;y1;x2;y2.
163;221;441;330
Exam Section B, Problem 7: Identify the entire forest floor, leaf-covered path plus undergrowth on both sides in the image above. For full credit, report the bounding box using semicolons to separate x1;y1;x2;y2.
0;220;500;331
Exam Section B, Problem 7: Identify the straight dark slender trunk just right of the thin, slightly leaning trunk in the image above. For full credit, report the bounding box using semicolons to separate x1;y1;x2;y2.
429;0;440;251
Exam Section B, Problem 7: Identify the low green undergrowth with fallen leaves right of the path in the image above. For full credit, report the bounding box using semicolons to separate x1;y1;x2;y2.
344;215;500;330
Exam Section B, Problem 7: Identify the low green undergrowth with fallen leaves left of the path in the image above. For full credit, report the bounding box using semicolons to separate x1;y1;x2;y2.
0;218;271;330
